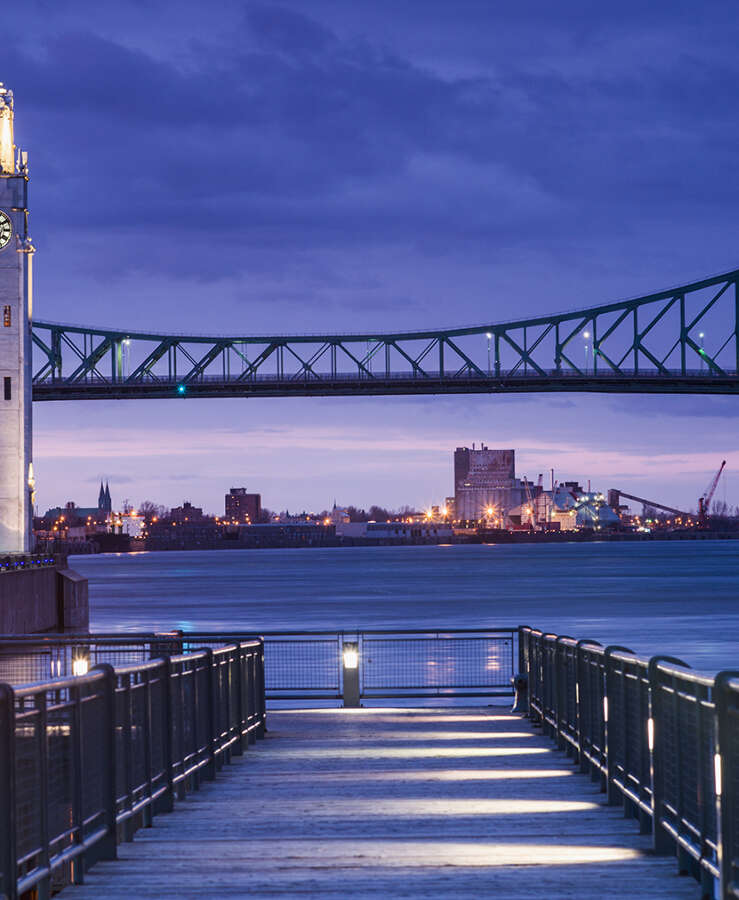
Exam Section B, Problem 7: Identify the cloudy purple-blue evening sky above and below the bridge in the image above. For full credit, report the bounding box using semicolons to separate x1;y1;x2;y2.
5;0;739;511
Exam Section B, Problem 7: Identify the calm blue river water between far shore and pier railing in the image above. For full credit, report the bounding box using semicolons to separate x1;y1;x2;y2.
71;541;739;670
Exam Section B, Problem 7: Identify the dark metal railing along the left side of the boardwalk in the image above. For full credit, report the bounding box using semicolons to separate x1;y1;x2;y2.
0;640;265;900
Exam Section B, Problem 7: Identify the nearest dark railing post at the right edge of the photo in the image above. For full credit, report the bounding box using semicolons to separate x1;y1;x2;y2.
713;672;739;900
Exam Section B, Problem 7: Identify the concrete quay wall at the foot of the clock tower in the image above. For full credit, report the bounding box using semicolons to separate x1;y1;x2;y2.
0;558;89;634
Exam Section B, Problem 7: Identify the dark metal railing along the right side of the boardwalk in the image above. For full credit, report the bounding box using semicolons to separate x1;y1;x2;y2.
519;626;739;900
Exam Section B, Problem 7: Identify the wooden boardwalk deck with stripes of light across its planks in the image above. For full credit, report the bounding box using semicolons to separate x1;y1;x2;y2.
63;707;700;900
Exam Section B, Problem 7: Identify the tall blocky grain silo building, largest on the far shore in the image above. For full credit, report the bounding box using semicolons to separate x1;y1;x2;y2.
454;444;523;520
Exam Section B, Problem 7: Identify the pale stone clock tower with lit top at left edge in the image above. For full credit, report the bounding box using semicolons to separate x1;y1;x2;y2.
0;82;34;553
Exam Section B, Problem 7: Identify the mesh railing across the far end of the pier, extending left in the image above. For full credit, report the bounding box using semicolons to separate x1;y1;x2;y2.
0;628;517;705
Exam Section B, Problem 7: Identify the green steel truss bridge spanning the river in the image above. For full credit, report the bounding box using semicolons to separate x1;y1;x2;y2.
33;270;739;400
